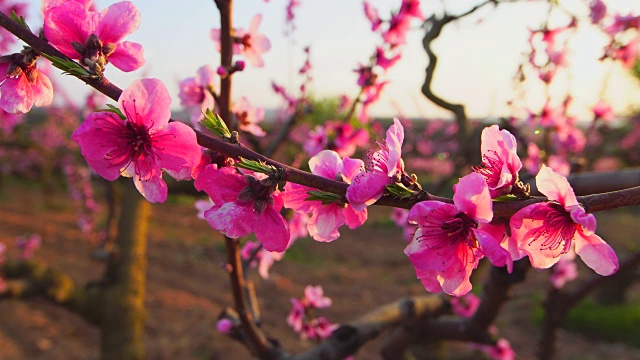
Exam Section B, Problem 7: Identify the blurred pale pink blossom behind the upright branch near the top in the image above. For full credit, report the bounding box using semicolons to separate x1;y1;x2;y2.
211;14;271;67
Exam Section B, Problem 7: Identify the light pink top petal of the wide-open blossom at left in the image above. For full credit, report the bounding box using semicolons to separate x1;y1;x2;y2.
118;79;171;129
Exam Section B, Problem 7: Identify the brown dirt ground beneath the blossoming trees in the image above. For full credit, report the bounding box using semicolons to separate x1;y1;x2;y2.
0;182;640;360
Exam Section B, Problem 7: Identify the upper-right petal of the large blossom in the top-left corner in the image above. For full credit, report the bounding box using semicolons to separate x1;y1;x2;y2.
96;1;140;44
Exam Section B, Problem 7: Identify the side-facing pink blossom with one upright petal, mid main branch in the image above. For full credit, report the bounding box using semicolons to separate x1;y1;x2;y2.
347;119;404;211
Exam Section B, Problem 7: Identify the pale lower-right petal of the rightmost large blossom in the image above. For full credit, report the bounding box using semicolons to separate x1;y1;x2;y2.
574;230;619;276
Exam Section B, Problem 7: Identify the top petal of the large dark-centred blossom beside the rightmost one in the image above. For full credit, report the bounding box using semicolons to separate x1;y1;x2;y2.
453;173;493;222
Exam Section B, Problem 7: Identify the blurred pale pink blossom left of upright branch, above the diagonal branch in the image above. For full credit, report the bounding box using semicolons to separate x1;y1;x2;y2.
178;65;217;125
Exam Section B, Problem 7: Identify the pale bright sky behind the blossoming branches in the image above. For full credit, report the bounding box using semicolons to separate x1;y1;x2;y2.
17;0;640;117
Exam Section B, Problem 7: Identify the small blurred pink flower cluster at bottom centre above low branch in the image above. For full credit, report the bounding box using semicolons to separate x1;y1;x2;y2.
287;285;339;341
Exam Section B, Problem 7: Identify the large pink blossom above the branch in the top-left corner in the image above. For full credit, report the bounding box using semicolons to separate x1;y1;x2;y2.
44;1;144;74
